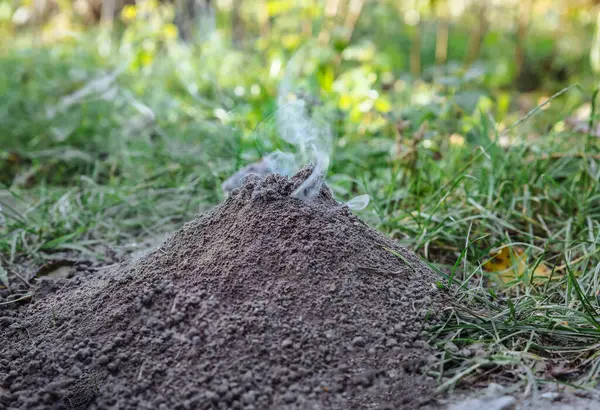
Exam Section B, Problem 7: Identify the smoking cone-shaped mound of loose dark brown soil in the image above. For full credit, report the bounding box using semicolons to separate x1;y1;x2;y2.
0;169;444;410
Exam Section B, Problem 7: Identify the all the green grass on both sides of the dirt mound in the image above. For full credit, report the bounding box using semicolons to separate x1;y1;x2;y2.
0;28;600;390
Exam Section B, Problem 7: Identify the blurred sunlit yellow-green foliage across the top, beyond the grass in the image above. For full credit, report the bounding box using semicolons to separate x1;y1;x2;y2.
0;0;598;147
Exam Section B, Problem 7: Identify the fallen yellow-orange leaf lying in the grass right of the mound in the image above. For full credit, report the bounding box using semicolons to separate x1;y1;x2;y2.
483;246;552;285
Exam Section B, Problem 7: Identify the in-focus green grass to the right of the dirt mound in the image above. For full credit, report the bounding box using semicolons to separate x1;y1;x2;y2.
365;122;600;390
